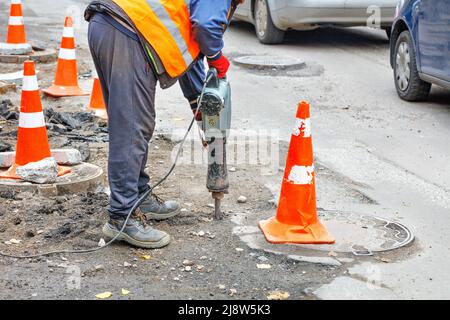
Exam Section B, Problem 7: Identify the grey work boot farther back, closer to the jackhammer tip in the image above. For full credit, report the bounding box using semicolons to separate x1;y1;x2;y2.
140;194;181;220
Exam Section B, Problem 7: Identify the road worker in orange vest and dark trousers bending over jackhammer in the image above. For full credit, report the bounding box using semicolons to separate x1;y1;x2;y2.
85;0;245;248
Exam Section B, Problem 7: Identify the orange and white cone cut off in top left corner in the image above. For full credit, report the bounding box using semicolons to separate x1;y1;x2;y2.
0;0;33;54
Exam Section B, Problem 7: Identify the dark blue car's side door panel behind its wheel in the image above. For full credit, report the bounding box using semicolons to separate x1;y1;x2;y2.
413;0;450;81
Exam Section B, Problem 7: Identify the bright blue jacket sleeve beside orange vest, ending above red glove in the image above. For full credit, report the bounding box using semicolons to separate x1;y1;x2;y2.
190;0;231;57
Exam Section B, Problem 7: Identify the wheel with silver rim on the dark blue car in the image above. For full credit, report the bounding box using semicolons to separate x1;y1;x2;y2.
394;31;431;101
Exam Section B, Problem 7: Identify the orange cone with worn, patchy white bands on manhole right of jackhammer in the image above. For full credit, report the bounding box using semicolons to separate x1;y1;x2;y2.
259;102;335;244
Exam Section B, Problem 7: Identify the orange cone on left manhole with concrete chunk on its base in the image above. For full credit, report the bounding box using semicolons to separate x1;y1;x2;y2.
0;61;70;179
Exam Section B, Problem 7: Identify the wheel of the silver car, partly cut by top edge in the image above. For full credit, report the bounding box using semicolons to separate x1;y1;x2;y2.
254;0;284;44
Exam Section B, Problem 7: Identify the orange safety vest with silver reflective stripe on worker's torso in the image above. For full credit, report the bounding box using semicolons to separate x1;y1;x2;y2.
113;0;200;78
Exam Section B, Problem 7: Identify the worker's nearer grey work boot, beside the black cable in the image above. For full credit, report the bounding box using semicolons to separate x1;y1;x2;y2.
103;209;170;249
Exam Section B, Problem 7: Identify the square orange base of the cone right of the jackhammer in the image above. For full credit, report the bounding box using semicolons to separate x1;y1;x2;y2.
259;218;335;244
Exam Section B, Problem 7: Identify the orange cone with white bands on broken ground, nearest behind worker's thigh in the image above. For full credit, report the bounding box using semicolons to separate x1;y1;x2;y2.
42;17;89;97
